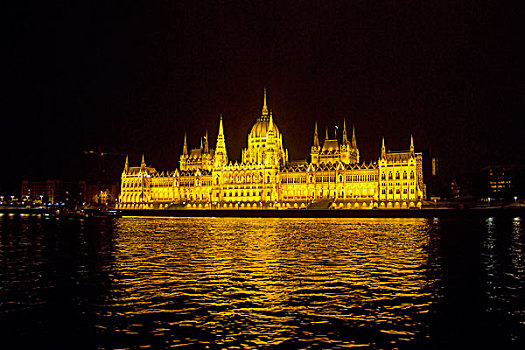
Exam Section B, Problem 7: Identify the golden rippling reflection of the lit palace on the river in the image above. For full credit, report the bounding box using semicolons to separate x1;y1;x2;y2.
100;218;433;348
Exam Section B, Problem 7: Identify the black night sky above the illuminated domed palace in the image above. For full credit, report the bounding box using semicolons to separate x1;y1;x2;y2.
0;0;525;196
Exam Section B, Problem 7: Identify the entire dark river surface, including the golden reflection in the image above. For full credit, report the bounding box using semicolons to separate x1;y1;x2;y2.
0;215;525;349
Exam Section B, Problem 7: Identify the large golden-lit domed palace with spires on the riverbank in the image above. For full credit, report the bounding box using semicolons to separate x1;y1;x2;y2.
118;90;425;209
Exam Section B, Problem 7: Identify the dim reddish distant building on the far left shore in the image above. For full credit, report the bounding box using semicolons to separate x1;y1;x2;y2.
21;180;86;204
